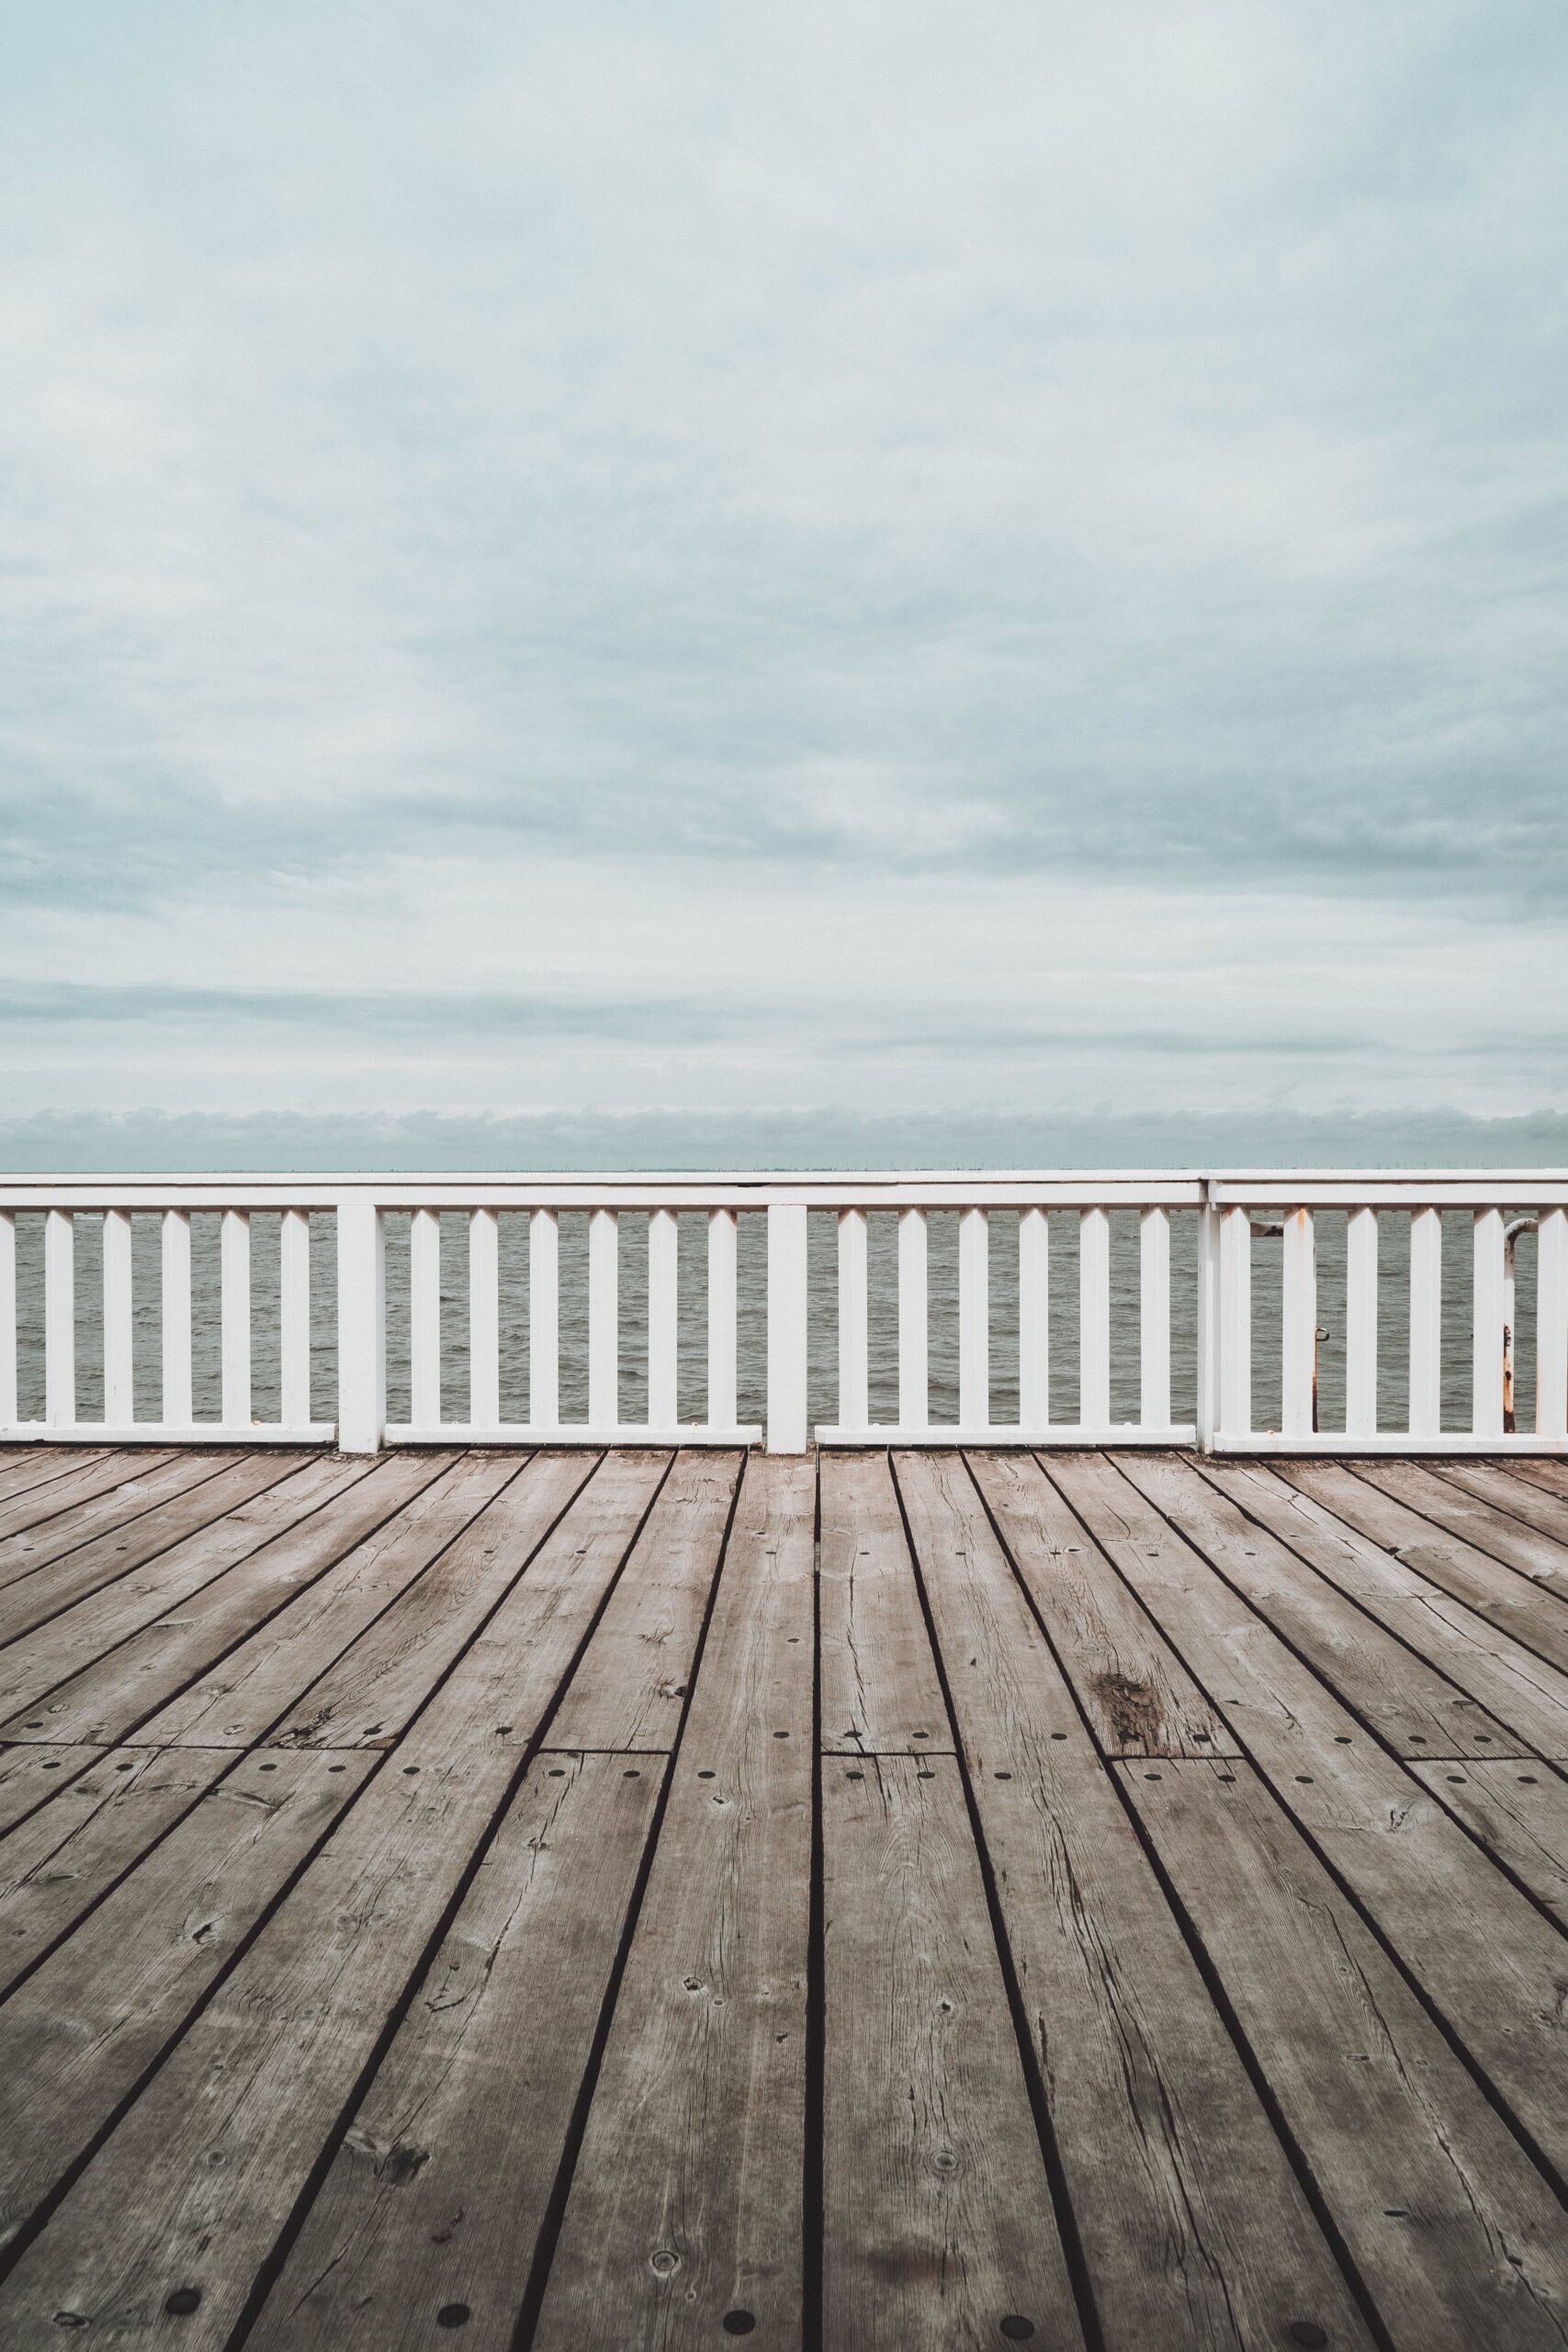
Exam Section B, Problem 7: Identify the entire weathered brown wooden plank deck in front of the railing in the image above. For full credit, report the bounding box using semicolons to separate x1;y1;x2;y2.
0;1449;1568;2352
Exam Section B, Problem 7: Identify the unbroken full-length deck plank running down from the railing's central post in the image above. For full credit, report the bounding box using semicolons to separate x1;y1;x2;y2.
534;1458;816;2352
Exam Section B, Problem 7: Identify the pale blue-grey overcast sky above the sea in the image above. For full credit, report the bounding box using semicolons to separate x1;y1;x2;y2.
0;0;1568;1143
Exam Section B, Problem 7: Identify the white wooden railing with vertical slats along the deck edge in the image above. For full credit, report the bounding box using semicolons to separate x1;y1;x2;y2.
0;1171;1568;1453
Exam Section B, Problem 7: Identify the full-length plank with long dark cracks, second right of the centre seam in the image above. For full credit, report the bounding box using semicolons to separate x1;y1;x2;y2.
900;1456;1366;2352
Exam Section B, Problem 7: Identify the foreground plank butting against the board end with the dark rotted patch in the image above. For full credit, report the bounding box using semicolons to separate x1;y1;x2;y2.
1122;1761;1568;2352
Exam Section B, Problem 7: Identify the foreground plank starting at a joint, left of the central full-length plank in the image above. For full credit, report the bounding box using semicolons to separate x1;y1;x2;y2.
247;1750;663;2352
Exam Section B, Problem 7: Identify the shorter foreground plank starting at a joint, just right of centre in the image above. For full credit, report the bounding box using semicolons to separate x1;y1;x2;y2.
823;1755;1084;2352
